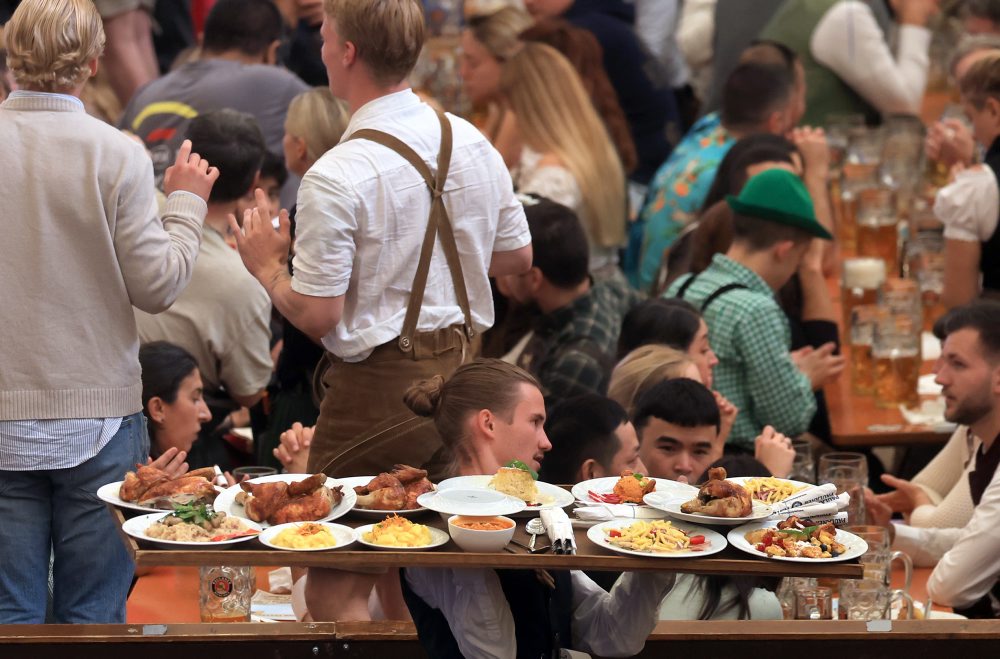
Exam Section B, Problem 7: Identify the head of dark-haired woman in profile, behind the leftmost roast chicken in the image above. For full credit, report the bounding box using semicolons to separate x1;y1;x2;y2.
139;341;212;471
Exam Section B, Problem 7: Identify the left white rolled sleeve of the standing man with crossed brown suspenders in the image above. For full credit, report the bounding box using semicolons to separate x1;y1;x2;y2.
292;160;361;297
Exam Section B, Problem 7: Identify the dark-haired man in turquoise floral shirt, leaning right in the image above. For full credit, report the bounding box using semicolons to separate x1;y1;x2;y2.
630;49;805;290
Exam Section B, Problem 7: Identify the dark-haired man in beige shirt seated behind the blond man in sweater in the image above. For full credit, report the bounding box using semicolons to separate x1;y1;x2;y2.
135;110;272;466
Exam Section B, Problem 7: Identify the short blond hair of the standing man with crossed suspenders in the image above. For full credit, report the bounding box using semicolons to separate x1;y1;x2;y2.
323;0;426;85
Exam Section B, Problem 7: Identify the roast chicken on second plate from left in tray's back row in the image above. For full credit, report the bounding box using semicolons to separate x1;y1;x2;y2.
236;474;344;525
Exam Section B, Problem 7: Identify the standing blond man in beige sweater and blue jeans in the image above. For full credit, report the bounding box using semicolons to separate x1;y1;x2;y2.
0;0;219;624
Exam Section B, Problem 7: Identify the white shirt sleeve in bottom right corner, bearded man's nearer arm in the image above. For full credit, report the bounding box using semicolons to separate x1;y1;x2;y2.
927;474;1000;607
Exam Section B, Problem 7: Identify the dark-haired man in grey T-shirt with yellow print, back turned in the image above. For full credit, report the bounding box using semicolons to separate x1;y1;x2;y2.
120;0;309;208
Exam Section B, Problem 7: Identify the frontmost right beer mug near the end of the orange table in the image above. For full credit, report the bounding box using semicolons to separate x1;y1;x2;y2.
872;313;921;408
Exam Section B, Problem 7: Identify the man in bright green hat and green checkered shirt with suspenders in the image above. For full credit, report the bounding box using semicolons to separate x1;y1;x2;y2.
668;169;843;452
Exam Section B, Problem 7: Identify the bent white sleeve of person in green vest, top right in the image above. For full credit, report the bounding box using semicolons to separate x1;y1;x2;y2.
809;0;931;114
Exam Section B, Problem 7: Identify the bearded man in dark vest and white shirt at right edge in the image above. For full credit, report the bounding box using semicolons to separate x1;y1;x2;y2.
866;301;1000;618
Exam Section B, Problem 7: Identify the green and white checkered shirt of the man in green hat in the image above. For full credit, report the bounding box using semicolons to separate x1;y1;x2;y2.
667;254;816;451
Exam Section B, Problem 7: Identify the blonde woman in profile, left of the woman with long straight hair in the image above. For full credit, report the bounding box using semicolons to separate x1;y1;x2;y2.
458;7;532;167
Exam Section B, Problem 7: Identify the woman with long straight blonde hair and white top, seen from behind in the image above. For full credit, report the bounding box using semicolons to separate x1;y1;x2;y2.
500;43;625;277
